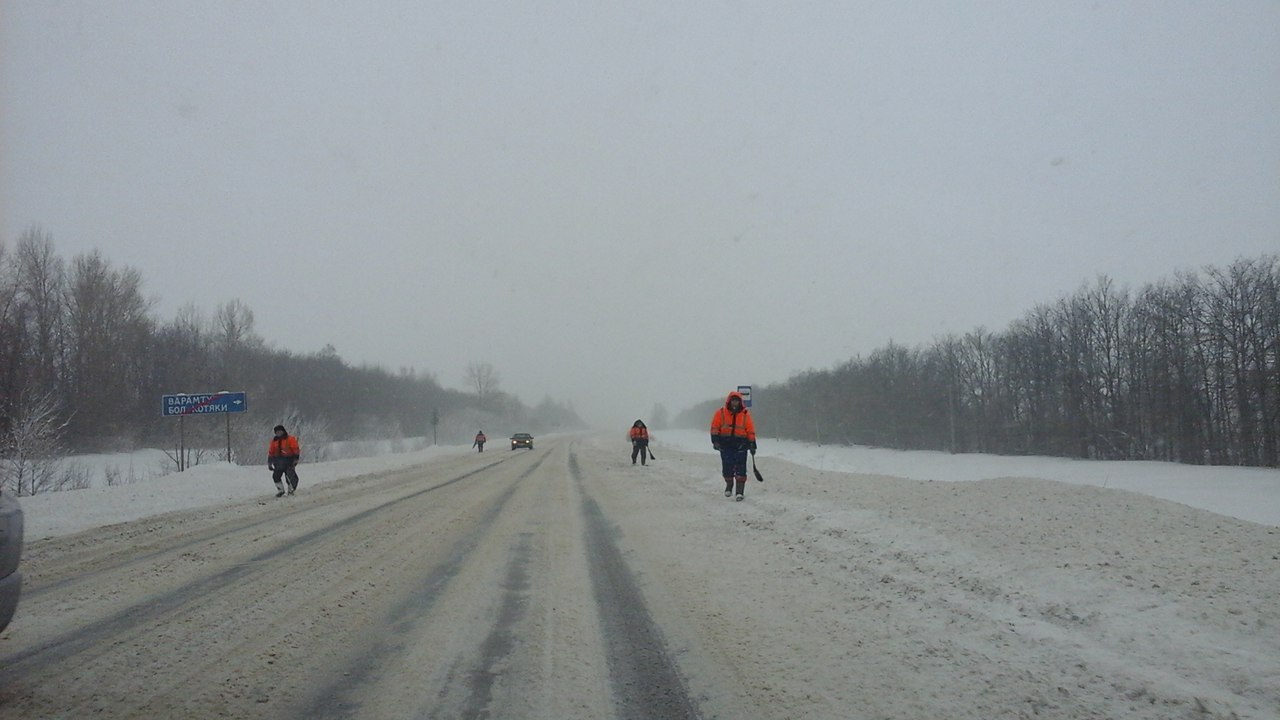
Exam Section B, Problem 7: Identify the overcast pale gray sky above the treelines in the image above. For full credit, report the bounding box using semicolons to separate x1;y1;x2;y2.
0;0;1280;424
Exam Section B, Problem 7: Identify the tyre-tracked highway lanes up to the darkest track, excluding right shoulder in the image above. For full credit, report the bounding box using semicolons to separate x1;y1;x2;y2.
0;443;695;717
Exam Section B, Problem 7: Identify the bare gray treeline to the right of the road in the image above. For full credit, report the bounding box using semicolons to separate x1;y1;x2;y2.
680;255;1280;468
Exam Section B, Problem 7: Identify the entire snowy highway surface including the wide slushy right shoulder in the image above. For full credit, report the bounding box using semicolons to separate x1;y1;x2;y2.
0;437;1280;720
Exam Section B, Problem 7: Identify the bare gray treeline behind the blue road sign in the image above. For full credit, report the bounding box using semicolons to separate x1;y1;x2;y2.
0;228;581;479
